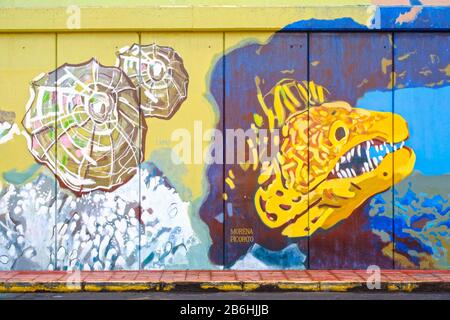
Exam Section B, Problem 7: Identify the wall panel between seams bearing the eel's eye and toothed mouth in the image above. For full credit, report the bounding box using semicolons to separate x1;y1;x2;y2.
309;33;393;269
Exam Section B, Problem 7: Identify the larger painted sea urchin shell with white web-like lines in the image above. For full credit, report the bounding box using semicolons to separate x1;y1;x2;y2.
23;59;146;194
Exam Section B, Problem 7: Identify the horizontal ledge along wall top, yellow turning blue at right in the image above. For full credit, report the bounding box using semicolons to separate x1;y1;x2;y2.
0;5;450;33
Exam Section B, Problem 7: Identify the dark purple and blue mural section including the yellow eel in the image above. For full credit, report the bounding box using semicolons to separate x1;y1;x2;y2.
199;30;450;269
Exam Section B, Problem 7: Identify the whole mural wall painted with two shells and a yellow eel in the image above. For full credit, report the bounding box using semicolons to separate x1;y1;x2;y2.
0;3;450;270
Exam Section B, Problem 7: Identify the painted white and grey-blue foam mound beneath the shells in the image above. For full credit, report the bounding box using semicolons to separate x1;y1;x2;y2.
0;167;198;270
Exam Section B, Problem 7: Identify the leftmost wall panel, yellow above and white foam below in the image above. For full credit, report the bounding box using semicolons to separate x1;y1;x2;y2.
0;34;56;270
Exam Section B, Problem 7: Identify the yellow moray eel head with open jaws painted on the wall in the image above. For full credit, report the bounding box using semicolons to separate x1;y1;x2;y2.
226;79;415;237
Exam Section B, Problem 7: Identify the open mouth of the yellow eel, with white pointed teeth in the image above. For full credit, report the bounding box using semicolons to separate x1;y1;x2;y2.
327;139;405;180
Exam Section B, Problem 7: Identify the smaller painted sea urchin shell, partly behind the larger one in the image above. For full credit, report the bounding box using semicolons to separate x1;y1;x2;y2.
118;44;189;119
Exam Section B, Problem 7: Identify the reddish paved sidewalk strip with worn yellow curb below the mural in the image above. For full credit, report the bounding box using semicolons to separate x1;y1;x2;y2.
0;270;450;293
